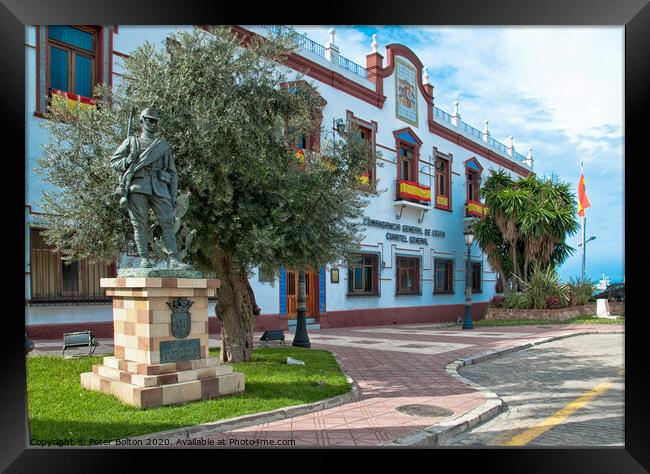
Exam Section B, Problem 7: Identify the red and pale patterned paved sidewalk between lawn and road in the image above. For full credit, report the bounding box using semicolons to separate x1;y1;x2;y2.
30;324;624;447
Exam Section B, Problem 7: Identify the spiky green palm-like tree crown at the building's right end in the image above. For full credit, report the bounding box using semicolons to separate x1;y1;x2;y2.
473;170;578;294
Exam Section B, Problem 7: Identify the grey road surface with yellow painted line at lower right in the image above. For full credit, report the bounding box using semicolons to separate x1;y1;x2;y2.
451;334;625;447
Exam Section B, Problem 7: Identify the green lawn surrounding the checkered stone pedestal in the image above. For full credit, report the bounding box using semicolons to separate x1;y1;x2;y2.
27;347;350;445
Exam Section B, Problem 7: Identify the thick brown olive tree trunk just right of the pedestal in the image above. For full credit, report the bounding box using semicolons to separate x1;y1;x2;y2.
213;248;259;362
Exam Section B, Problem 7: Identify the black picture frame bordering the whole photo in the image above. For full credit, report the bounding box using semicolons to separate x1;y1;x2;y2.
0;0;650;473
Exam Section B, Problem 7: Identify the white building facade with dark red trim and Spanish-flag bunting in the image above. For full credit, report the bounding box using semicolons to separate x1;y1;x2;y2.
25;26;532;338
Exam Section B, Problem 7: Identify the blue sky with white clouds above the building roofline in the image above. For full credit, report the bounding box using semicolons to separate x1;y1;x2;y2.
295;26;625;281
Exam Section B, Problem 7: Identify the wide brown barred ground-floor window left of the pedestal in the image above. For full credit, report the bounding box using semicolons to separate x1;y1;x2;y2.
30;229;117;304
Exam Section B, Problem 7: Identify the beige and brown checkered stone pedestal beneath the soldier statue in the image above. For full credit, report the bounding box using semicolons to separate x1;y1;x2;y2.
81;277;244;408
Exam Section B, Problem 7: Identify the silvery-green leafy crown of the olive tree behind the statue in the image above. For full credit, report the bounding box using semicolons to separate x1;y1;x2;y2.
39;27;374;274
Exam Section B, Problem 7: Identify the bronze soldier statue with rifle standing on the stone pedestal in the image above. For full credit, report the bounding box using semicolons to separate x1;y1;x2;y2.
111;108;188;268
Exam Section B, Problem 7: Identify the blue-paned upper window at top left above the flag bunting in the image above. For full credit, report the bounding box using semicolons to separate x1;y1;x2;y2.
47;26;97;98
